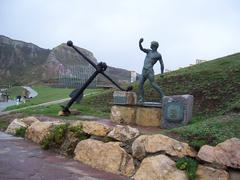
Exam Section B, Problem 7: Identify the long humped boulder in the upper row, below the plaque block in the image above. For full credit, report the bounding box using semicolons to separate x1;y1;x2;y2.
132;134;196;160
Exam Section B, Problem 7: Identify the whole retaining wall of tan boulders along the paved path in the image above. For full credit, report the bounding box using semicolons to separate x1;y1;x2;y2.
4;118;240;180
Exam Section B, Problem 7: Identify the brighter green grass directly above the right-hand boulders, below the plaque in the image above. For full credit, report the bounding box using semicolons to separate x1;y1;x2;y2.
163;114;240;150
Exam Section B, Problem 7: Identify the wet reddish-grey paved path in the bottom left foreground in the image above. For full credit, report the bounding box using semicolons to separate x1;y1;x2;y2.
0;132;127;180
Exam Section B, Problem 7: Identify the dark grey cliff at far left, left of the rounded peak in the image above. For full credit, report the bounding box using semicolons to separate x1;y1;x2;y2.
0;36;50;84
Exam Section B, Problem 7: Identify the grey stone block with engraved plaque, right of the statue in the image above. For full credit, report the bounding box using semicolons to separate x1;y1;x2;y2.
161;95;193;128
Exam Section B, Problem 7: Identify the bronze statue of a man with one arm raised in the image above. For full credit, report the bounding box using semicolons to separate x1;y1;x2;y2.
139;38;164;103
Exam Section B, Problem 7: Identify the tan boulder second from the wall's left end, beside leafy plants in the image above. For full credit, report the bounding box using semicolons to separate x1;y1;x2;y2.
25;121;63;144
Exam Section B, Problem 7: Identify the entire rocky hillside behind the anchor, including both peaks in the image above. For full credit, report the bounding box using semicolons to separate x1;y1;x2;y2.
0;35;130;86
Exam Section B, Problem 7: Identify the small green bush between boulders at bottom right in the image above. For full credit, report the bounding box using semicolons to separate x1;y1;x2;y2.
176;157;198;180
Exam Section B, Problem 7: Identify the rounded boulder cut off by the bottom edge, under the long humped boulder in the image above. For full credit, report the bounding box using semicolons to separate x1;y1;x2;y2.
133;155;188;180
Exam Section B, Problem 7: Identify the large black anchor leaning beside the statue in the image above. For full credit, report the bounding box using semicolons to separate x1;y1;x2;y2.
59;41;132;116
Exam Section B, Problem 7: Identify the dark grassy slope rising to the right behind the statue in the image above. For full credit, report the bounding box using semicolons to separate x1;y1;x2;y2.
139;53;240;114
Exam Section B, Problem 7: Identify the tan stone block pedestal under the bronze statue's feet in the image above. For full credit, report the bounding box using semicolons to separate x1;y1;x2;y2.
111;105;161;127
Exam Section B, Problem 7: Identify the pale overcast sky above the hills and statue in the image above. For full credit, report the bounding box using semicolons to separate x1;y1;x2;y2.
0;0;240;73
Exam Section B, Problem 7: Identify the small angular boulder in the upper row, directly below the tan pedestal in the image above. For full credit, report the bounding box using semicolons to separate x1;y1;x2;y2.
107;125;140;142
